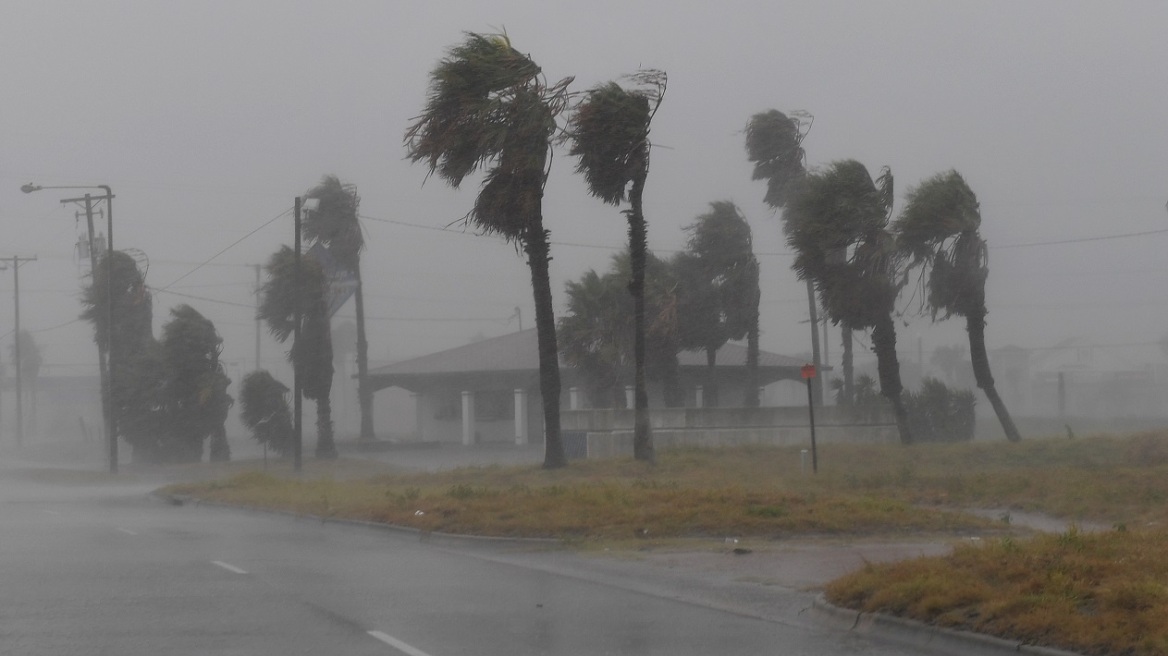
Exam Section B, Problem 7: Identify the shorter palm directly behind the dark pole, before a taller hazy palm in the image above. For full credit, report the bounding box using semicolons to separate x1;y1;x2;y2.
257;246;336;459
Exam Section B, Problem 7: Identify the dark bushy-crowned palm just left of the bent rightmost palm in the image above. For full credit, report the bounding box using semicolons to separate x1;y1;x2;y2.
783;160;912;444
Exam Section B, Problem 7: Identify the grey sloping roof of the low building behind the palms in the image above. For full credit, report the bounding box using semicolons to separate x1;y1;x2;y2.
369;328;805;378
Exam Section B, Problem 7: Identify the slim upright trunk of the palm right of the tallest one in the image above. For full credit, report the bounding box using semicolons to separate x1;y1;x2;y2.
627;174;655;462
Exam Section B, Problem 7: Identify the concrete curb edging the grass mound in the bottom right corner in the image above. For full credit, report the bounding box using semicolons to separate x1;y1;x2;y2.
812;595;1082;656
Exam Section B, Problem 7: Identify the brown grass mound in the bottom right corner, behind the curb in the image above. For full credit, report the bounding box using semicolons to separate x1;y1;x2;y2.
826;528;1168;656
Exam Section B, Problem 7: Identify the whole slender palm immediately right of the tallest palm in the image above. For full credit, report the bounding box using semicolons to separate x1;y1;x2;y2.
570;70;666;462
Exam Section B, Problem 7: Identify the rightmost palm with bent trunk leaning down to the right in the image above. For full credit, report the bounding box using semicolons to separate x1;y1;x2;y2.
894;170;1022;442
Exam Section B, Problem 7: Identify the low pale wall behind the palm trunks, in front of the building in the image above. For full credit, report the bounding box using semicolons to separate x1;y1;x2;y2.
561;407;899;458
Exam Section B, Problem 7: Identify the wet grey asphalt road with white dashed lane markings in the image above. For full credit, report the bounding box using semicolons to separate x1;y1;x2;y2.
0;448;934;656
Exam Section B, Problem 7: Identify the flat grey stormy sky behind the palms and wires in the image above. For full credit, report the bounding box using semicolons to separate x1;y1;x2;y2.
0;0;1168;382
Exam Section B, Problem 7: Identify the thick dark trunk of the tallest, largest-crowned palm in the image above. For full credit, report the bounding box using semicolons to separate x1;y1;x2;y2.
523;221;568;469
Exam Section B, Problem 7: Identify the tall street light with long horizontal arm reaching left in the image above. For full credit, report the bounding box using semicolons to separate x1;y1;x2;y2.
20;182;118;474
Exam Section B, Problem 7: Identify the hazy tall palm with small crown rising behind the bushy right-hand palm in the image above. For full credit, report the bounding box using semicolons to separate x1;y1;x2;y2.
745;110;836;404
